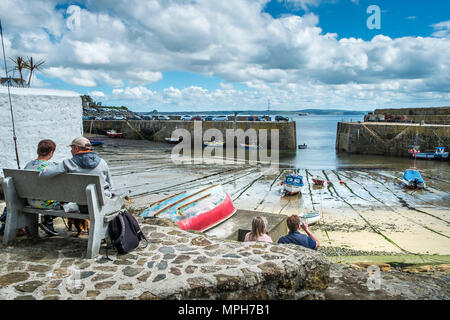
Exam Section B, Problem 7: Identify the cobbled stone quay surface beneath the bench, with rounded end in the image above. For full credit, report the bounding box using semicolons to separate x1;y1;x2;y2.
0;220;330;300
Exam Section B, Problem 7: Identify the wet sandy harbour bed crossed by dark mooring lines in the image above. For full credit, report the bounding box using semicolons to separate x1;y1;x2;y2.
97;139;450;255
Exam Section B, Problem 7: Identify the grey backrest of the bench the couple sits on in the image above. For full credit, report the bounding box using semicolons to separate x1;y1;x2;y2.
3;169;105;206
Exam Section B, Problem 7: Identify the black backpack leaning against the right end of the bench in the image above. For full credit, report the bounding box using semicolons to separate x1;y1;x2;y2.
106;210;148;257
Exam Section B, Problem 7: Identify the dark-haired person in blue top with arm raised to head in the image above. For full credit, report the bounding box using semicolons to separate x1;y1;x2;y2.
278;214;320;249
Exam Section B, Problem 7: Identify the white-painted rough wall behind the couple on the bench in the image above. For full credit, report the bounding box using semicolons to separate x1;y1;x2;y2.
0;87;83;176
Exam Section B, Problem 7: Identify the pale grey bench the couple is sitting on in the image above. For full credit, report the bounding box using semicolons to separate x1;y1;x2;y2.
2;169;124;259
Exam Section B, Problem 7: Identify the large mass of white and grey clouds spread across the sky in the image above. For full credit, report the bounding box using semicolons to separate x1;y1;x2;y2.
0;0;450;110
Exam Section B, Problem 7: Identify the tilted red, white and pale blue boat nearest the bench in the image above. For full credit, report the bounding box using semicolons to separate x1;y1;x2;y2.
141;185;236;231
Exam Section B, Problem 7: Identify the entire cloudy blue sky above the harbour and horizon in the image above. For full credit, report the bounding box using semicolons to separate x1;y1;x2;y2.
0;0;450;112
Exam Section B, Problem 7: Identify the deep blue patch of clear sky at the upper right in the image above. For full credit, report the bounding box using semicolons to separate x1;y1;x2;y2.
264;0;450;41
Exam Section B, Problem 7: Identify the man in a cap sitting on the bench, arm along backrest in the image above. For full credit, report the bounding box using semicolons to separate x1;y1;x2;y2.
39;137;113;213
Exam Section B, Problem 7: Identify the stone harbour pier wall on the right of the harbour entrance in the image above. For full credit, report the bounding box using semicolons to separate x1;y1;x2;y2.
336;122;450;157
